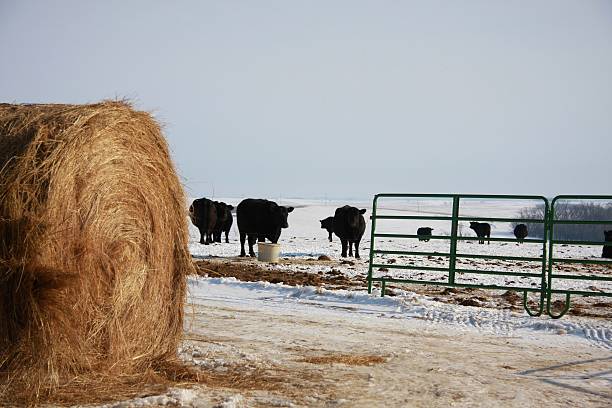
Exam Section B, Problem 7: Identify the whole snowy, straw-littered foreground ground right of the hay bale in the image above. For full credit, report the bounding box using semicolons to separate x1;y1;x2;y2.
94;277;612;408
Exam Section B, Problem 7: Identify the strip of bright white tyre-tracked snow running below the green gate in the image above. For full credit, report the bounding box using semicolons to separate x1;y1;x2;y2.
189;278;612;350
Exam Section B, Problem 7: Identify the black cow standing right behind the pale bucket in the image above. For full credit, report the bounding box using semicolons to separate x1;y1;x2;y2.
236;198;293;256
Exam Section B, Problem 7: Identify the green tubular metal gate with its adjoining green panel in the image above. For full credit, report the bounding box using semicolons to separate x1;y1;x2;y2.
367;194;612;318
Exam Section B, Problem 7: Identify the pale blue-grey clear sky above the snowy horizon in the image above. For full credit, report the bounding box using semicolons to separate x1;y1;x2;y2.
0;0;612;198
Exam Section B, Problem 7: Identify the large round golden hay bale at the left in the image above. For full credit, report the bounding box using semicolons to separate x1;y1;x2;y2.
0;102;193;405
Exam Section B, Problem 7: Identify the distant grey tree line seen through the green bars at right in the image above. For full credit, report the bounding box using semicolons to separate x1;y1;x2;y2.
512;203;612;241
